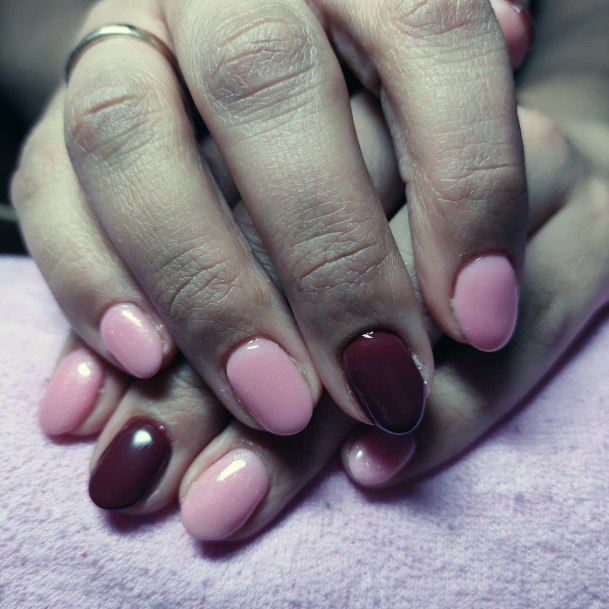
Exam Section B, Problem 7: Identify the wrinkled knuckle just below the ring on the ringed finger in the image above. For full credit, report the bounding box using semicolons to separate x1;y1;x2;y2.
65;69;166;162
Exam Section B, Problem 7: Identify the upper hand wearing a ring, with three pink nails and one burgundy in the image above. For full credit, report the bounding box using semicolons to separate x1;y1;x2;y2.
12;0;526;434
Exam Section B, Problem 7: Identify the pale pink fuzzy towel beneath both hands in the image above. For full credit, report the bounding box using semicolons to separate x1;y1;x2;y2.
0;258;609;609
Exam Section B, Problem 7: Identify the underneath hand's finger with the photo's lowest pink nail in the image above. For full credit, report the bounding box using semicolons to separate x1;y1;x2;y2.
180;396;354;541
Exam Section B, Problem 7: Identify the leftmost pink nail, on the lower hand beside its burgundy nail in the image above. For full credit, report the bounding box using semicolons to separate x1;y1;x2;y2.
38;349;104;435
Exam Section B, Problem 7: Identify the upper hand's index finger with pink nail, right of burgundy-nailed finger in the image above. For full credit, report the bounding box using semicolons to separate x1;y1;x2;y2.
323;0;527;351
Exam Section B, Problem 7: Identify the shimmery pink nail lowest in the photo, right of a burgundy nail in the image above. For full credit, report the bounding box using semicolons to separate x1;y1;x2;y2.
182;449;271;541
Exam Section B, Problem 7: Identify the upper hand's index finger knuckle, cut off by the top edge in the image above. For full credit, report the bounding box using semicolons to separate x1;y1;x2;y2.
379;0;488;40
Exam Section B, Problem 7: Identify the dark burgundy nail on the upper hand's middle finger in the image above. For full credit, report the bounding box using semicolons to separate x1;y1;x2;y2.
342;331;426;434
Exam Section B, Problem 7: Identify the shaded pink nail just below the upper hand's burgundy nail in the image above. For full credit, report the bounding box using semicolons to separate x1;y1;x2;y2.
345;429;415;486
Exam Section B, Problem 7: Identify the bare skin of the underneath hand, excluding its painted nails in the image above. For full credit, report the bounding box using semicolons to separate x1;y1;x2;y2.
29;97;609;539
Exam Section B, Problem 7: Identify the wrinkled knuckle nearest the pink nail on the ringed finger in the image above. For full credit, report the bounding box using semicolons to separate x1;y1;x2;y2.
153;243;251;326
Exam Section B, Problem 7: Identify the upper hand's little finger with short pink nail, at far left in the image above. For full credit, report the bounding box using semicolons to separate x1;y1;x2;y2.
11;89;175;378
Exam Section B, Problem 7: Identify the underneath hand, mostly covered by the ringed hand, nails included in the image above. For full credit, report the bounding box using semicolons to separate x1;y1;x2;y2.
34;95;592;539
